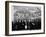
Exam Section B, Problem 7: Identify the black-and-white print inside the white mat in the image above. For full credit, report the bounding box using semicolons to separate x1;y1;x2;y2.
11;6;41;31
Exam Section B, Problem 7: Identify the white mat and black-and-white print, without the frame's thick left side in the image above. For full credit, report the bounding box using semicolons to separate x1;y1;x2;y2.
7;2;44;35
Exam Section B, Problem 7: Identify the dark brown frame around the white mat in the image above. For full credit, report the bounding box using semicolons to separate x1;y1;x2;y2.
5;1;45;36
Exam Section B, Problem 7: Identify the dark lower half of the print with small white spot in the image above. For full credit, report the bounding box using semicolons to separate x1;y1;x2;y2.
12;20;41;31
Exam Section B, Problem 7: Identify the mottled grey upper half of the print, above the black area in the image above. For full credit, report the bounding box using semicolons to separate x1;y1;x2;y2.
11;6;41;20
